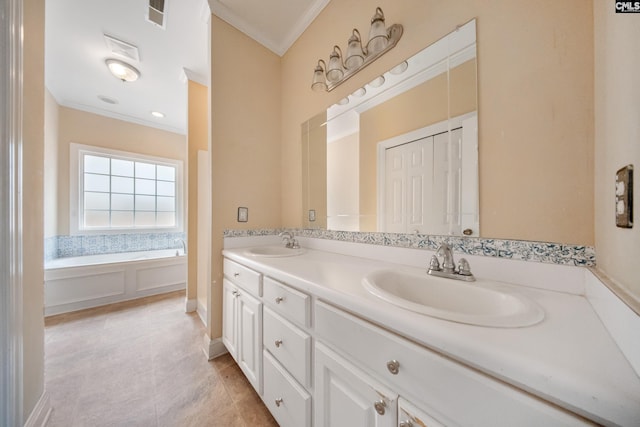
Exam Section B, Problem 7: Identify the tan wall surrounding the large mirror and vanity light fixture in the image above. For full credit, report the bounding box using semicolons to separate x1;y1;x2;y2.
282;0;594;245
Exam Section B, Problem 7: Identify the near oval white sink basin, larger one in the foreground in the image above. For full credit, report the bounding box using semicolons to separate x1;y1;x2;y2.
363;270;544;328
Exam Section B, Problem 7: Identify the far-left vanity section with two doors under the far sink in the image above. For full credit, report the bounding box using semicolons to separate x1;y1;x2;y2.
222;260;262;394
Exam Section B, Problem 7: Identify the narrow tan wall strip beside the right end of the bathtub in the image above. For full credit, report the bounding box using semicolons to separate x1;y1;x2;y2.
187;81;209;300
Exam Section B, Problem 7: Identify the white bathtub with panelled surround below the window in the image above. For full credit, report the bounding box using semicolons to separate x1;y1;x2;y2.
44;249;187;316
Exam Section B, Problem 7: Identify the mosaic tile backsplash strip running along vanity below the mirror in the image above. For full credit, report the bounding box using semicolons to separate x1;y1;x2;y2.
224;229;596;267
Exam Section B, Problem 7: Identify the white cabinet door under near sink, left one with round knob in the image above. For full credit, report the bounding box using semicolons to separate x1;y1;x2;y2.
314;343;398;427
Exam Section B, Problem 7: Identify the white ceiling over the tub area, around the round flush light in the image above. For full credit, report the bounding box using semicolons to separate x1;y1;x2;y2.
45;0;209;134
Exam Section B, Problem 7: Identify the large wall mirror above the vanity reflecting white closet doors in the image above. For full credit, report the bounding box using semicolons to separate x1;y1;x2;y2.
301;20;480;236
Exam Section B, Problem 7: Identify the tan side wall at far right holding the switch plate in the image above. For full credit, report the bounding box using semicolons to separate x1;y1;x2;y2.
594;0;640;304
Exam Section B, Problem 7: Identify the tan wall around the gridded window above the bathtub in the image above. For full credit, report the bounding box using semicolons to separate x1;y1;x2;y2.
57;107;187;235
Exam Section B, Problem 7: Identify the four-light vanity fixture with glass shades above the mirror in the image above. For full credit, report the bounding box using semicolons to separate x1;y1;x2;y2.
311;7;403;91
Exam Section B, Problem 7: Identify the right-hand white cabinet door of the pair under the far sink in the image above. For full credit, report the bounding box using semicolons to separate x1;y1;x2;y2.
236;290;262;394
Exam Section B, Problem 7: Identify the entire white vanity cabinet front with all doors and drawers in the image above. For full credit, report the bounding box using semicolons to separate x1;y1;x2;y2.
223;258;593;427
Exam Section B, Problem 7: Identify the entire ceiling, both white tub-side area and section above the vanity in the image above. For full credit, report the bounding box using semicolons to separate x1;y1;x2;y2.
45;0;330;134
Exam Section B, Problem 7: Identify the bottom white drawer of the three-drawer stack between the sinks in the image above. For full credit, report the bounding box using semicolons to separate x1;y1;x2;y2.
264;351;311;427
